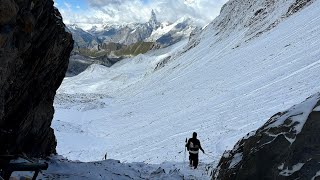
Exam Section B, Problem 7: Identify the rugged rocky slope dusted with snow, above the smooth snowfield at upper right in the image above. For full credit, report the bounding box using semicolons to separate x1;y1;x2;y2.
190;0;316;51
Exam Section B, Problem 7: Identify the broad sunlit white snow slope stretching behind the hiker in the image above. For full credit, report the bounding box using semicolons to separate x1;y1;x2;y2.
52;1;320;179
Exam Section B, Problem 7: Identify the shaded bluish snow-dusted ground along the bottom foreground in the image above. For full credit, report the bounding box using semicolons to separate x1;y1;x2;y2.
11;156;209;180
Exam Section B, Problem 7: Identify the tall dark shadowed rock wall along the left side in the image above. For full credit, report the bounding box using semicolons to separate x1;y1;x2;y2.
0;0;73;157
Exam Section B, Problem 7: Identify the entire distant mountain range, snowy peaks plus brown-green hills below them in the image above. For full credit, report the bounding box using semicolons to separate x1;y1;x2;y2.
67;10;198;76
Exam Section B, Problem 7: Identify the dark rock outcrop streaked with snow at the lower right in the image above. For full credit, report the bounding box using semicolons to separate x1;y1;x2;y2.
213;93;320;180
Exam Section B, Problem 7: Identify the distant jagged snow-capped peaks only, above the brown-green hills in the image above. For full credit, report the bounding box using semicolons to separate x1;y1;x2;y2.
68;10;197;49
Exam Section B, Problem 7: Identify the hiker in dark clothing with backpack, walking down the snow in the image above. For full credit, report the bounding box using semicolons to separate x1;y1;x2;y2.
186;132;204;169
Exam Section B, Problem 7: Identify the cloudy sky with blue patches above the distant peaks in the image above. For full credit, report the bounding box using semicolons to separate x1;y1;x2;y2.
54;0;228;29
